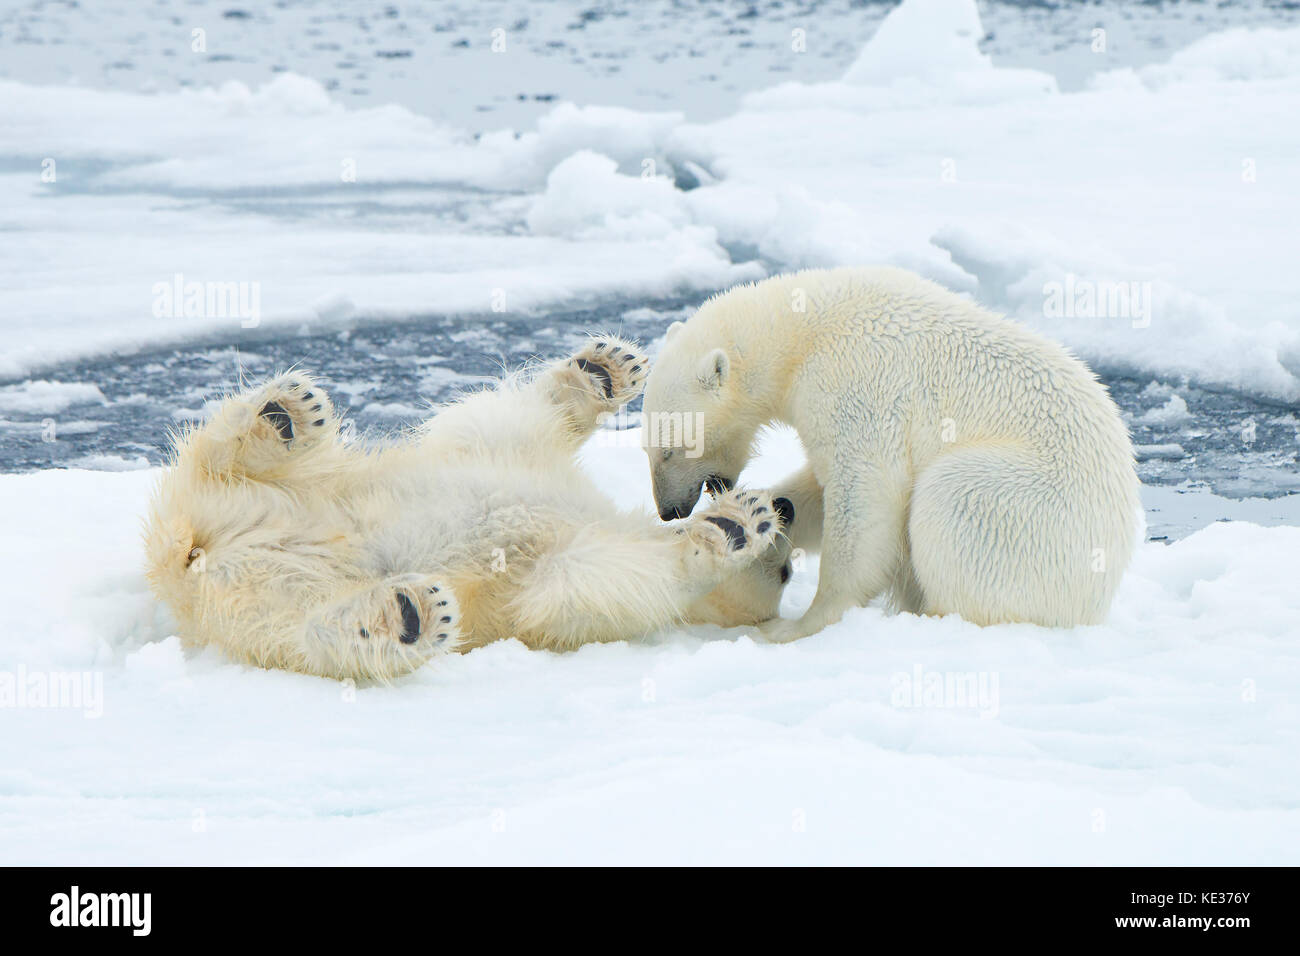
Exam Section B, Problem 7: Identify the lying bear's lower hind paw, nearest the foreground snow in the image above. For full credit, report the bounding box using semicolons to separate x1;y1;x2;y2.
302;574;460;678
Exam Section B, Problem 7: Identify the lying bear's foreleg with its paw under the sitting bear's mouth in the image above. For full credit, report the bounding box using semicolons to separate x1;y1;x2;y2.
511;490;781;648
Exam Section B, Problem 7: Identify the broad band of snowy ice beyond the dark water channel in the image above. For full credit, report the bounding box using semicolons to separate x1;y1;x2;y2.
0;0;1300;402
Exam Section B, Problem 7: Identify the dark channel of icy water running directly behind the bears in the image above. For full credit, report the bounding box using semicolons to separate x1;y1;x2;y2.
0;303;1300;498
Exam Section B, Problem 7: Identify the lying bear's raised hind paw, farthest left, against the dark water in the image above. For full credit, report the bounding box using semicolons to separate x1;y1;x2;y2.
183;372;338;480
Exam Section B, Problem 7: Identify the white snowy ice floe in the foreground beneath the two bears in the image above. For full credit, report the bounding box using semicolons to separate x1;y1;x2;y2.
0;434;1300;865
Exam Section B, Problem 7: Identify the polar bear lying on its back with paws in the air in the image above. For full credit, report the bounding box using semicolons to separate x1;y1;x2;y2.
146;337;793;679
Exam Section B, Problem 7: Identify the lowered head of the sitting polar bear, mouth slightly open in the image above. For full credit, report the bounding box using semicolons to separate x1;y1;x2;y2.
644;323;763;522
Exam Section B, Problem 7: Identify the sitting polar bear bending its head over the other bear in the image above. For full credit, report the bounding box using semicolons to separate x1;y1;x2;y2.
645;268;1139;640
